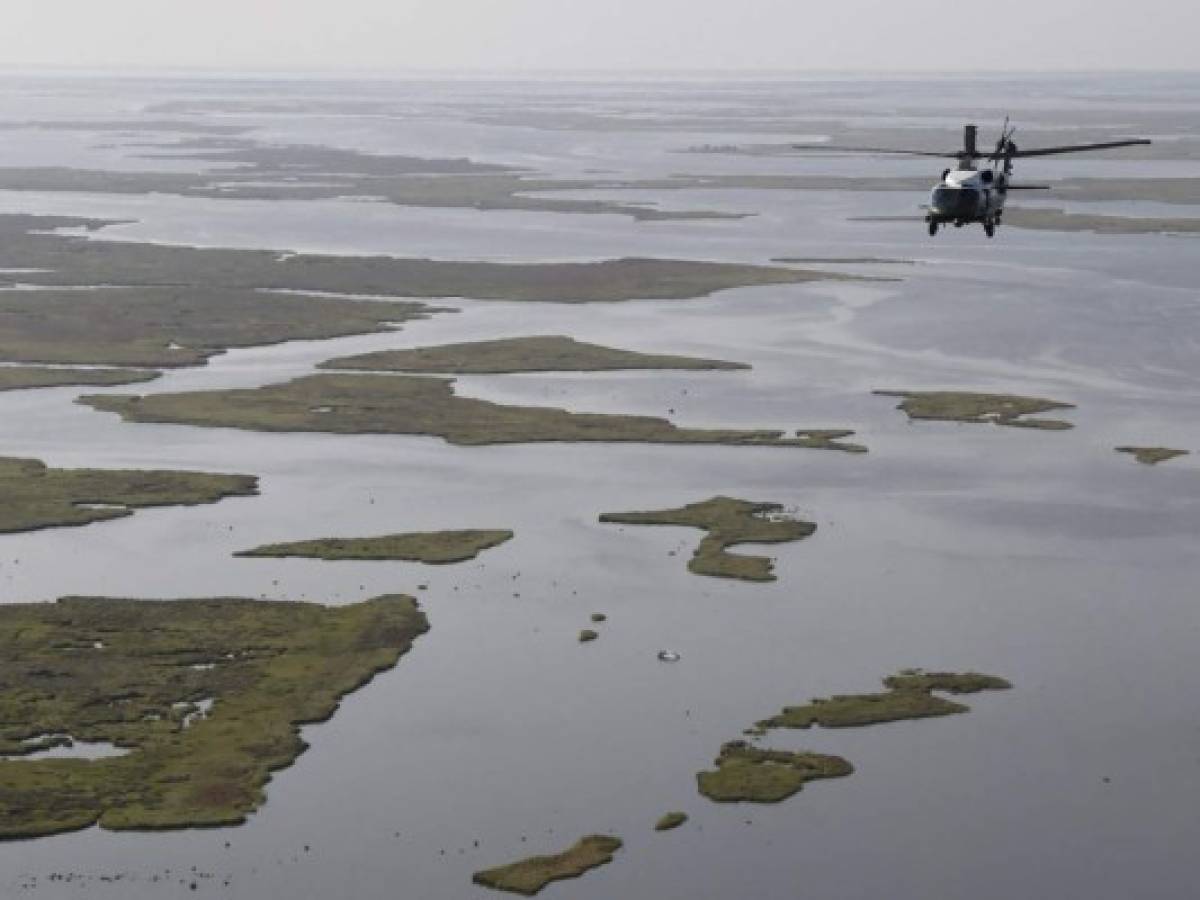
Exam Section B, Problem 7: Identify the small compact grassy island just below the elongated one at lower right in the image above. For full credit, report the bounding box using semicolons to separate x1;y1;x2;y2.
696;740;854;803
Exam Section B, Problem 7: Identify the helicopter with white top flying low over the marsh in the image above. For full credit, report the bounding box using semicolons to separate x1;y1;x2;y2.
793;119;1151;238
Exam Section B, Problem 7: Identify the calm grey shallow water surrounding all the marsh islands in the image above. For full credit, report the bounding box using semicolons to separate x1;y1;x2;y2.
0;78;1200;900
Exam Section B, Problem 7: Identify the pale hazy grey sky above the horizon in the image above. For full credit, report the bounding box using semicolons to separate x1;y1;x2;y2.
0;0;1200;70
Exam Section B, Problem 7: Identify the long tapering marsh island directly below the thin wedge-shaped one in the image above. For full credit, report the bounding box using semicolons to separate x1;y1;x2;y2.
79;374;864;448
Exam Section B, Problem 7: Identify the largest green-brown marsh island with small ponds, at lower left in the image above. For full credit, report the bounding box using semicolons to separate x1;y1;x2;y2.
0;595;428;839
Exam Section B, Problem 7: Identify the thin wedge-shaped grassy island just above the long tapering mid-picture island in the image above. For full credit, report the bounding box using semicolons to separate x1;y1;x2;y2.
319;335;750;374
